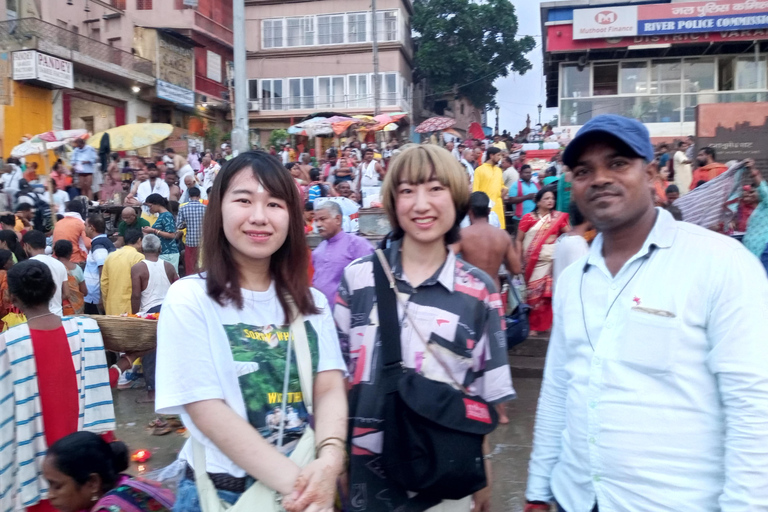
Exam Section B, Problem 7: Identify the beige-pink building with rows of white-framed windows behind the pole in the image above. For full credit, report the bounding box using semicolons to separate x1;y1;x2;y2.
246;0;413;145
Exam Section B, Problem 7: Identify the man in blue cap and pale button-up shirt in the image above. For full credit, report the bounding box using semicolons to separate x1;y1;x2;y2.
526;115;768;512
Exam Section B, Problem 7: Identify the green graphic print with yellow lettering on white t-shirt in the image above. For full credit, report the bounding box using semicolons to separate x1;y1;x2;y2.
224;321;318;454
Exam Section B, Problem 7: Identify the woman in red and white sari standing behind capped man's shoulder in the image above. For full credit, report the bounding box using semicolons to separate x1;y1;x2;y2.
517;187;570;335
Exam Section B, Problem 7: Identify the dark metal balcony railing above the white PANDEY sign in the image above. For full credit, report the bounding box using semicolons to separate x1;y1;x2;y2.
0;18;155;77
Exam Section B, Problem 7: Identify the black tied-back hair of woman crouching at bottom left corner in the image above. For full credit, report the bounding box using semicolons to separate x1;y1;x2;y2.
48;431;128;492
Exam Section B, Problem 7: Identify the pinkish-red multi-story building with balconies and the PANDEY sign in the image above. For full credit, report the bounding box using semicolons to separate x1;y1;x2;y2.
0;0;232;157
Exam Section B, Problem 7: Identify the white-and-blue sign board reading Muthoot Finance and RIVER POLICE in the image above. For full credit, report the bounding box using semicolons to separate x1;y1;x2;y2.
573;0;768;39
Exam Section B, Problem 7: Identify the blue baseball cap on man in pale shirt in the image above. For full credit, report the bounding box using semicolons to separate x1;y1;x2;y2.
563;114;655;167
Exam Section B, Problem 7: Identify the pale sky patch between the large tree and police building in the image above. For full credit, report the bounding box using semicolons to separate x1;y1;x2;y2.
488;0;557;135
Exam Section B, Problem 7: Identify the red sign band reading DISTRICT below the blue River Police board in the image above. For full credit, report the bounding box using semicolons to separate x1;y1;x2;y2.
547;25;768;52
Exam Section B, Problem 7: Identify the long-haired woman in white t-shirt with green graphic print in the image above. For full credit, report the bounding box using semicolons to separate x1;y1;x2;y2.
156;152;347;512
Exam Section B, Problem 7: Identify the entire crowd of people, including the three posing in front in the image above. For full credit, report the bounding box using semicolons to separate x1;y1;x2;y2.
0;115;768;512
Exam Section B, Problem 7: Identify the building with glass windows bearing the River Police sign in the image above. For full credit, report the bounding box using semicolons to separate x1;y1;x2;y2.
541;0;768;139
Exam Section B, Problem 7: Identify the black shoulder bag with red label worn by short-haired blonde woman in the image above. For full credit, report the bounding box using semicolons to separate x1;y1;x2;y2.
373;250;498;510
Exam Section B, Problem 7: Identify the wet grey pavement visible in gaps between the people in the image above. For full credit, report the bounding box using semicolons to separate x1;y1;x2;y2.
113;378;541;512
